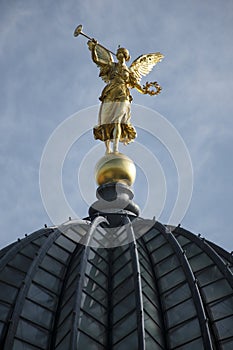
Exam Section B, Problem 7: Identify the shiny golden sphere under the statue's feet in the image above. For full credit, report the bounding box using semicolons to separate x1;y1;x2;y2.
95;153;136;186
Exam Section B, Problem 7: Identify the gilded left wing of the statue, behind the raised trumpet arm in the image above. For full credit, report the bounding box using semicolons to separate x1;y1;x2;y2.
87;40;114;83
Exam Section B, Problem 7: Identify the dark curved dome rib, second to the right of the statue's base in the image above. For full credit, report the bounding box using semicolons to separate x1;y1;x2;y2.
164;226;213;350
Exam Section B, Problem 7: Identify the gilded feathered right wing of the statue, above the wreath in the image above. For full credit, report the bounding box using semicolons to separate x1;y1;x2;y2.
129;52;164;84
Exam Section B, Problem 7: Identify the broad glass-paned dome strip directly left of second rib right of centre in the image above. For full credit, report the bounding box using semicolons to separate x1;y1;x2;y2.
144;223;204;349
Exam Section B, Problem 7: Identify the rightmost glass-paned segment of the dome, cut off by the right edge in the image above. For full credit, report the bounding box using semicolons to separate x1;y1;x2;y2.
173;227;233;349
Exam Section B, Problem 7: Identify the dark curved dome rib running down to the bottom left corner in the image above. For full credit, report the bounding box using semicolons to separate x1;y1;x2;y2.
5;230;60;349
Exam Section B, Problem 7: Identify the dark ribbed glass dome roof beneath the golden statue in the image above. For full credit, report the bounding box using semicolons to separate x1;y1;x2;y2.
0;214;233;350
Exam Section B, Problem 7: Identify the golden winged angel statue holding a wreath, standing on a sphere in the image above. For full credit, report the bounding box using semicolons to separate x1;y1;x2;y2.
87;39;163;153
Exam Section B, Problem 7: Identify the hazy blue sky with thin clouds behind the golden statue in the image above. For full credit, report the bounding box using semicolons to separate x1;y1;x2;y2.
0;0;233;251
